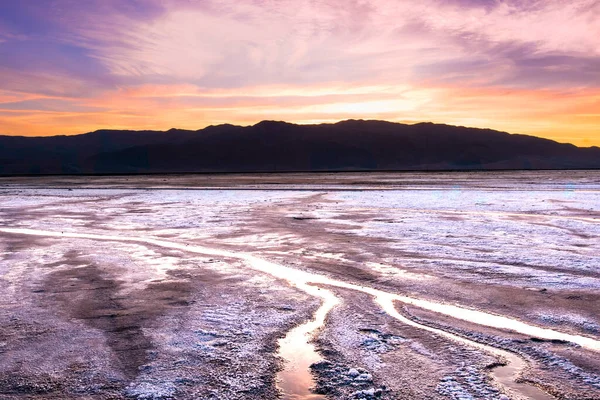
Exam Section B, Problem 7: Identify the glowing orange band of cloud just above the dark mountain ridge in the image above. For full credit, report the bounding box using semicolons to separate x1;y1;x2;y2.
0;83;600;146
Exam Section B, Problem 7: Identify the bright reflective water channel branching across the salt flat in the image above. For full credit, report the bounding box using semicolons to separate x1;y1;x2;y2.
0;228;600;400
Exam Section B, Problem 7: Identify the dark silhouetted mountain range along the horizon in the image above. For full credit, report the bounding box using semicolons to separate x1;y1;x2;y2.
0;120;600;175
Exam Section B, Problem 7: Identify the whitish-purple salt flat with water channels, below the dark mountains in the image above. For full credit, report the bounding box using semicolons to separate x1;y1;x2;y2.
0;171;600;400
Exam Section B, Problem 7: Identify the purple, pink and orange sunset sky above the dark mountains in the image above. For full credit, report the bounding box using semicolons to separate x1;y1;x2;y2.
0;0;600;146
